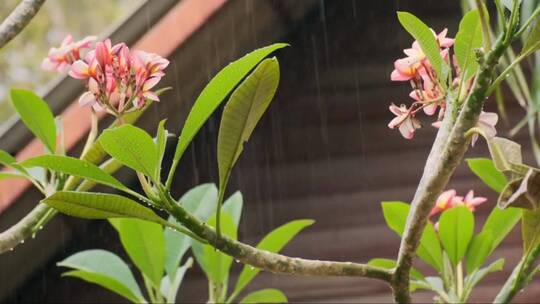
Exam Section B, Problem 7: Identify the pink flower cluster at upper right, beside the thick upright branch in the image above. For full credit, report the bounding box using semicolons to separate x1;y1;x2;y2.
388;29;497;142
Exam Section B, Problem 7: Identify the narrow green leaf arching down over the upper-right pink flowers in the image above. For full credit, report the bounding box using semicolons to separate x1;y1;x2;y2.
397;12;446;86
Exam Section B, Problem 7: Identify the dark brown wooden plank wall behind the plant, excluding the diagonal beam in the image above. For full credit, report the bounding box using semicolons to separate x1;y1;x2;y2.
5;0;540;303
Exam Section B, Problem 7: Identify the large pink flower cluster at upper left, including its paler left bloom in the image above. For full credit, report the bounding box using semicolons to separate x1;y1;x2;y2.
42;36;169;116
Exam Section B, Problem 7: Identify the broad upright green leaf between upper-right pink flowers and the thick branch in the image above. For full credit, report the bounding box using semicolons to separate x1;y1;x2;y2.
454;9;483;81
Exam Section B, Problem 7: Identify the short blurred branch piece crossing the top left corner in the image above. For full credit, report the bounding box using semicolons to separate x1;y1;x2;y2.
0;0;45;49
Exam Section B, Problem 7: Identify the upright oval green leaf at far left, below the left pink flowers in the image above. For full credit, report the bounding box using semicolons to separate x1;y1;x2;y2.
11;89;56;153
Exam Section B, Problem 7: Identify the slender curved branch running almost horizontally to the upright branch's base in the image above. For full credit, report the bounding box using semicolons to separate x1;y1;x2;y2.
168;199;392;282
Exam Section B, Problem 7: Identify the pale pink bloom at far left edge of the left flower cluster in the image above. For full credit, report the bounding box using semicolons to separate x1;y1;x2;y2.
41;35;96;72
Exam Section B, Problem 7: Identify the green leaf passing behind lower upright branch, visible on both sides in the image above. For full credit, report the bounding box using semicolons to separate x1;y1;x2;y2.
382;202;442;271
